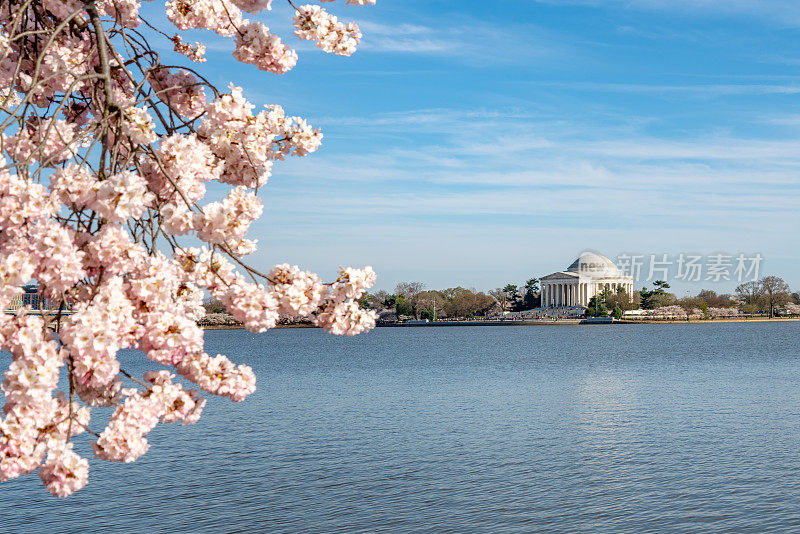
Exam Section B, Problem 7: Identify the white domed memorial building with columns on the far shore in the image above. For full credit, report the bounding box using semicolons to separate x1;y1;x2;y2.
540;252;633;308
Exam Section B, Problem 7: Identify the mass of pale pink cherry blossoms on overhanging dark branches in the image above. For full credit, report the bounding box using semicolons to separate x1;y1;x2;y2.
0;0;375;497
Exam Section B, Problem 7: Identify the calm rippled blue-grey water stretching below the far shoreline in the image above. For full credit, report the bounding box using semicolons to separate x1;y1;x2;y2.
0;323;800;533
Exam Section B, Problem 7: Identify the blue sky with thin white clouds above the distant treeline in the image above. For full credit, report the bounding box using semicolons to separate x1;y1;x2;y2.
150;0;800;296
